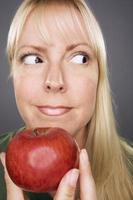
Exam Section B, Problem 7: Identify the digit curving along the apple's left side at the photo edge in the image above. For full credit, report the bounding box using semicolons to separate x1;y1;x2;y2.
0;152;24;200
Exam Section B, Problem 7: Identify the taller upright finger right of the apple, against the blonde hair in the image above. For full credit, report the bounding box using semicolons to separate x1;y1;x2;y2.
79;149;97;200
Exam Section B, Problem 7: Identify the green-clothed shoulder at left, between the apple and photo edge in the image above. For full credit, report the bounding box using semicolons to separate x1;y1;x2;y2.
0;127;24;152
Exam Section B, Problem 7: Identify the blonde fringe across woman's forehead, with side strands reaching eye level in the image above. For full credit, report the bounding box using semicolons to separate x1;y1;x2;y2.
7;0;106;65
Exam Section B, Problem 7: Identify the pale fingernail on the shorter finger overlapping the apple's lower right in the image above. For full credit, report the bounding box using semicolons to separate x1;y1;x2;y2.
66;169;79;186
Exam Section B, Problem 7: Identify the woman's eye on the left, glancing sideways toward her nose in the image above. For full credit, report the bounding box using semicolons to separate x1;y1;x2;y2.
21;54;43;65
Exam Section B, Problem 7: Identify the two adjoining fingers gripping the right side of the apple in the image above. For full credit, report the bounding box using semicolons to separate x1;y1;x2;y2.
54;149;97;200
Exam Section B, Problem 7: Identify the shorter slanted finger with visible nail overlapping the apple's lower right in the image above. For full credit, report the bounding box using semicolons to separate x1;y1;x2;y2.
54;169;79;200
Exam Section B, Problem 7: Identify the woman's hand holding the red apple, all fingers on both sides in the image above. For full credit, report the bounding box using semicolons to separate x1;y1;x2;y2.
0;149;97;200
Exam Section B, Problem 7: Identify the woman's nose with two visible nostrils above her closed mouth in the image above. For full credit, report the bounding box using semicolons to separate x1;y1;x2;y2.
44;68;66;93
